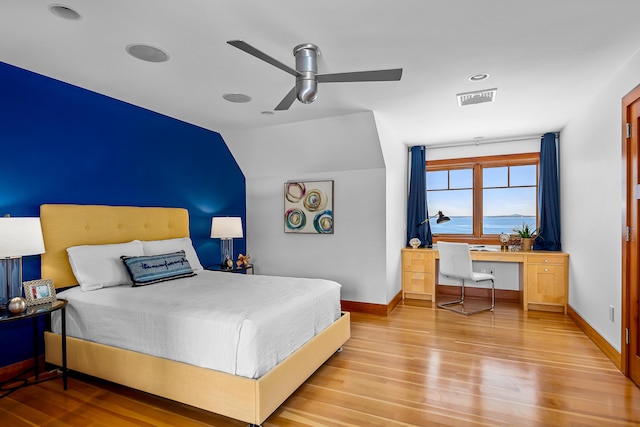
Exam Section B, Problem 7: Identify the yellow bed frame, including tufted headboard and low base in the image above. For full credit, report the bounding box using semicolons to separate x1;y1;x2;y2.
40;204;350;425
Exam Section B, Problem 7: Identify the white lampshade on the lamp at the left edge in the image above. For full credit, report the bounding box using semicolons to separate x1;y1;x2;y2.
0;217;44;258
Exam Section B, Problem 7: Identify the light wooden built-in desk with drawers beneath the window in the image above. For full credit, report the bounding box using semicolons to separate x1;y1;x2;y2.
402;248;569;314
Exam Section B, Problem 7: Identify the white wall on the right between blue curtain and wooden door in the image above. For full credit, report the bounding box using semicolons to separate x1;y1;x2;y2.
560;49;640;351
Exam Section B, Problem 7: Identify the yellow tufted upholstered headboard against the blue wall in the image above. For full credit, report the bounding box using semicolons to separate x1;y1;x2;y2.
40;204;189;288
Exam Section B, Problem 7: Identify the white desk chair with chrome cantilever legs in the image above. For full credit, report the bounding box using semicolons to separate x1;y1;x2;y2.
438;242;495;315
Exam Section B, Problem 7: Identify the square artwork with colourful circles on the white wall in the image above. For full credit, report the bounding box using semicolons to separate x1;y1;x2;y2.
284;181;333;234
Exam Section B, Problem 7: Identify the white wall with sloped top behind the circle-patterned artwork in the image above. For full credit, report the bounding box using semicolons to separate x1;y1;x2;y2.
223;112;387;304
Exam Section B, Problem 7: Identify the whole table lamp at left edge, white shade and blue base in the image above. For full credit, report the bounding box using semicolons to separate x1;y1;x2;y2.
0;219;44;309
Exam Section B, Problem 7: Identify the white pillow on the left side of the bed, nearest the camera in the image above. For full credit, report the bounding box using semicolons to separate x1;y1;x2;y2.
67;240;144;292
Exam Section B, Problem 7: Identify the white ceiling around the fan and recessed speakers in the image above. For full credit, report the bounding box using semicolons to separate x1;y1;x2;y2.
0;0;640;145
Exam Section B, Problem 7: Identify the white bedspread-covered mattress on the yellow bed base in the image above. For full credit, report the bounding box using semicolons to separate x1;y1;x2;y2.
52;270;340;378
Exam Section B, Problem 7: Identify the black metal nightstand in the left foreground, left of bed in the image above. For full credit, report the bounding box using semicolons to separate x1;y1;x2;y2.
0;299;67;399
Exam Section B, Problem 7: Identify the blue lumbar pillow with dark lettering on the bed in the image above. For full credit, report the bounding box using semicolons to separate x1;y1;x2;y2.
120;251;196;286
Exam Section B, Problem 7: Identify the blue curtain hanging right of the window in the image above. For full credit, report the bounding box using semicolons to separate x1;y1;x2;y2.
534;132;562;251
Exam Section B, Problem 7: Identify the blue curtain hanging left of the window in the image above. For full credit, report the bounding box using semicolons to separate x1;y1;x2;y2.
407;145;432;246
